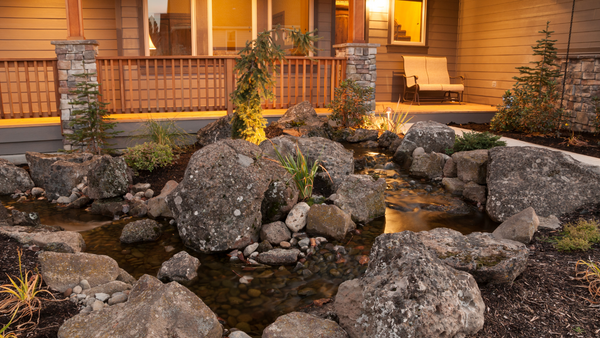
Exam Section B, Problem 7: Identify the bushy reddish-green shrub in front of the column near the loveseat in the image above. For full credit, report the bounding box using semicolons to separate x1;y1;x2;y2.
327;80;373;128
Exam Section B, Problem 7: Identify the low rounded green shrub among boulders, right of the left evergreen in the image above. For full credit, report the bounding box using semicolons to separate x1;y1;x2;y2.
123;142;174;171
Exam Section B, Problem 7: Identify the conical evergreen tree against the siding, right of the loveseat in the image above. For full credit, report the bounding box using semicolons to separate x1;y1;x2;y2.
491;21;562;134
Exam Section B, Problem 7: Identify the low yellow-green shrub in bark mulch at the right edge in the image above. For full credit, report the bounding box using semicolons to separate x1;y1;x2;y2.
554;220;600;251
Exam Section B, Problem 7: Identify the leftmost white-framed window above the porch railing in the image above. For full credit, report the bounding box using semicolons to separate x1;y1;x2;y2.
148;0;192;55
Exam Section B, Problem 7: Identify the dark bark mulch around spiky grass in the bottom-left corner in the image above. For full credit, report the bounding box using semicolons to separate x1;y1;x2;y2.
0;235;79;338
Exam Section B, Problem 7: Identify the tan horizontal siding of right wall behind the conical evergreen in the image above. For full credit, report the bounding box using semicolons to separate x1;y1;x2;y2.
457;0;600;105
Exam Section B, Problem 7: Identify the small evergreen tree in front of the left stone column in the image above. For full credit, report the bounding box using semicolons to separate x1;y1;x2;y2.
65;67;119;155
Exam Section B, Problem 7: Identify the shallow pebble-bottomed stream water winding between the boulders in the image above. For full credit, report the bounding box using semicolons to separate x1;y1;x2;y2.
1;146;497;337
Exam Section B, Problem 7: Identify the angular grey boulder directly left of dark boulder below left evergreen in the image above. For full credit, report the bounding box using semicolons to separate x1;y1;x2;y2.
45;156;99;200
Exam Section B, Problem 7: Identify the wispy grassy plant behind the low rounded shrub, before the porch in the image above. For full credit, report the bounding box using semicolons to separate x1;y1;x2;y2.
131;118;191;150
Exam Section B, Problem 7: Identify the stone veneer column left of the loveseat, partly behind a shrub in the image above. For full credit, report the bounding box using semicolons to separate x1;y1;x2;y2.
333;43;380;110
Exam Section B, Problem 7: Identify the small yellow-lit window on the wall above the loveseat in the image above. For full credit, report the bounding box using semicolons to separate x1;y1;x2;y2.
390;0;427;46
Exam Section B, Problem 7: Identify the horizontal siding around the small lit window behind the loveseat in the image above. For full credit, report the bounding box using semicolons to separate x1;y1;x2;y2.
368;0;459;102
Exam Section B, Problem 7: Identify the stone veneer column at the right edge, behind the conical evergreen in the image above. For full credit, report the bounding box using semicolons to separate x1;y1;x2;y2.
558;55;600;132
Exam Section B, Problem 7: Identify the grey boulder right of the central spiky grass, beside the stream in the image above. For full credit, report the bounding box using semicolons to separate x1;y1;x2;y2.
330;175;387;224
